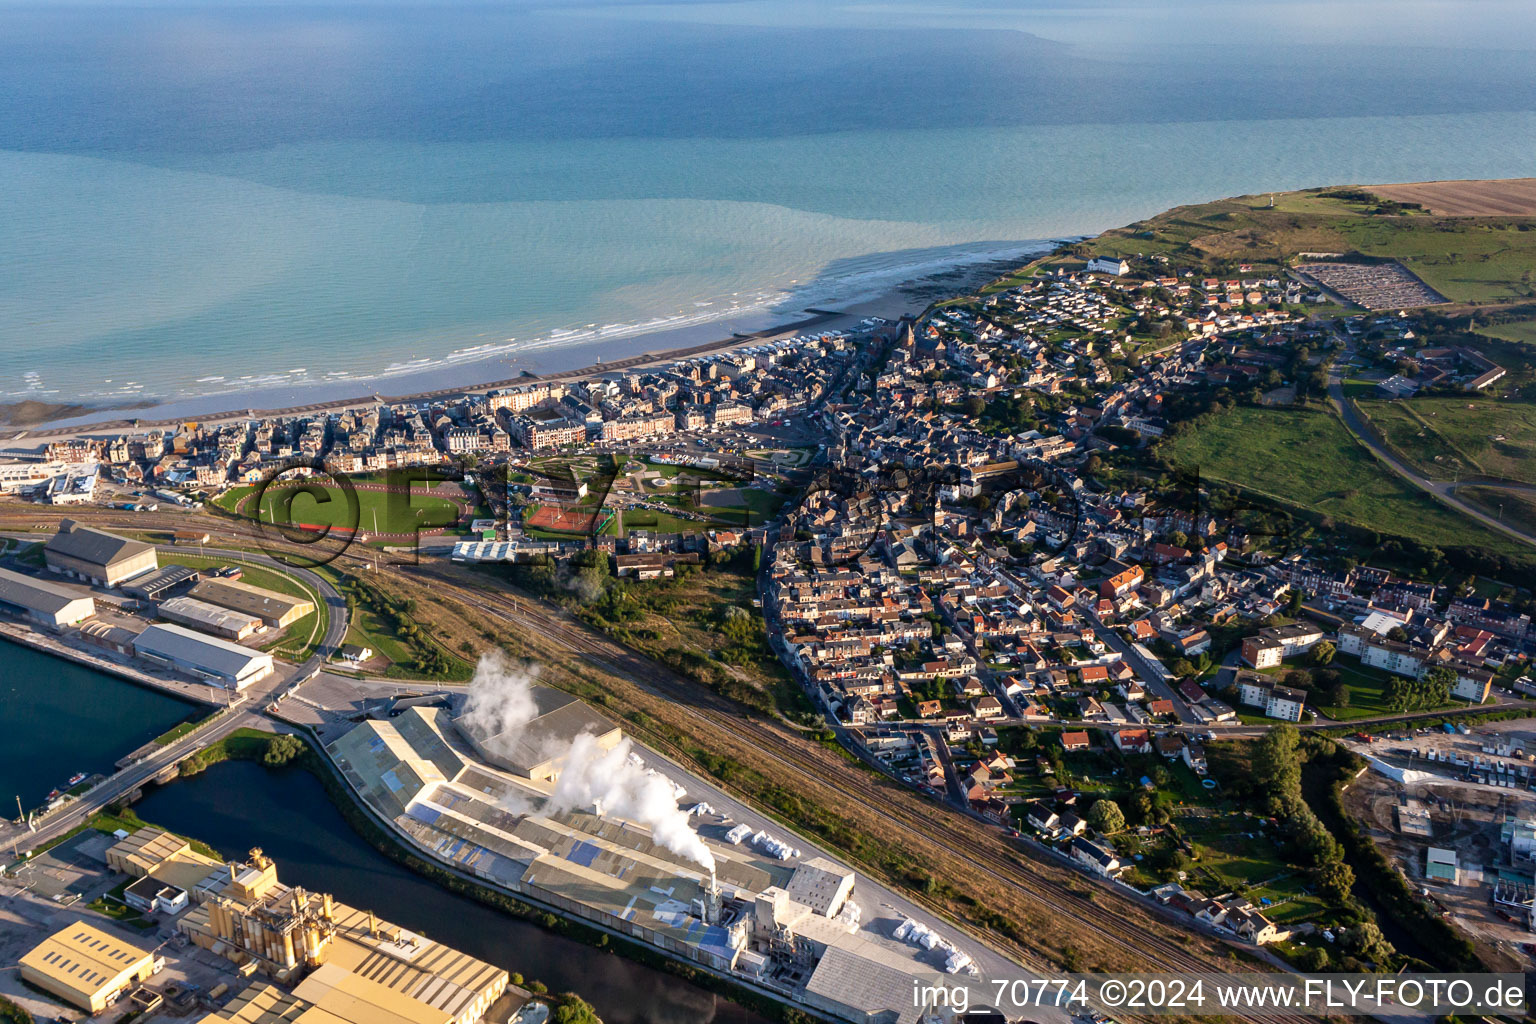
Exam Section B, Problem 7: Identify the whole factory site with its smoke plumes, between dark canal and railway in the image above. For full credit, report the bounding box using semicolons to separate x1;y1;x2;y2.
327;682;1017;1024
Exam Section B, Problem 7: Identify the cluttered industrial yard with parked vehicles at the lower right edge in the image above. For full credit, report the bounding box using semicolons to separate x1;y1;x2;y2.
1344;720;1536;966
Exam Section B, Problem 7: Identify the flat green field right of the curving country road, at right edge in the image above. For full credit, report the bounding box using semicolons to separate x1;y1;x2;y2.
1359;396;1536;484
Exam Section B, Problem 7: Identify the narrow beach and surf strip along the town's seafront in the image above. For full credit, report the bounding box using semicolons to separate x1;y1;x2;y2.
0;248;1055;453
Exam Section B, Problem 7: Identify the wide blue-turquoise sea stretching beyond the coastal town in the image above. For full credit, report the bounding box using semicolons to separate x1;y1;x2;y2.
0;0;1536;408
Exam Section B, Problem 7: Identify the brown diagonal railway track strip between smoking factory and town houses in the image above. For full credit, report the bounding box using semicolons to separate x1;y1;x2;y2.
413;568;1309;1024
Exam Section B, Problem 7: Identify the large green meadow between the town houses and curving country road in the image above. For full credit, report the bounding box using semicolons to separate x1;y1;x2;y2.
1160;407;1527;553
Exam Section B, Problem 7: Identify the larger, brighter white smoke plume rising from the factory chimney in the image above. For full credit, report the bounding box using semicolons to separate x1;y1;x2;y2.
550;732;714;875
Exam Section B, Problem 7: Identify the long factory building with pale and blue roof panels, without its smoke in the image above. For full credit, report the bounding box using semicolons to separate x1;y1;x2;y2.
327;706;952;1024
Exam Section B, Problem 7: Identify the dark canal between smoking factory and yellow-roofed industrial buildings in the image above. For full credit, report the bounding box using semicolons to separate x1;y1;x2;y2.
135;761;765;1024
